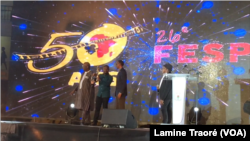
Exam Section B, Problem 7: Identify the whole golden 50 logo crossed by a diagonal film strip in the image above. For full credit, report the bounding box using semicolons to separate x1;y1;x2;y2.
15;24;143;73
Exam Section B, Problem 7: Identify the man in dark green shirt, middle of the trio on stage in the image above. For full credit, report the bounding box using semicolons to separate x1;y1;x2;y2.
93;65;113;125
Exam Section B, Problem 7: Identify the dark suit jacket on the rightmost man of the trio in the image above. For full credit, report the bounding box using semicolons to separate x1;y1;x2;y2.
115;68;127;96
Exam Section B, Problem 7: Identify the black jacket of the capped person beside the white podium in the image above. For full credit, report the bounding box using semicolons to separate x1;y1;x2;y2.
158;77;172;101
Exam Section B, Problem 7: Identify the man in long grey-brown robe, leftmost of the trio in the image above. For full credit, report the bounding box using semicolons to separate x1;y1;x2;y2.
71;62;96;125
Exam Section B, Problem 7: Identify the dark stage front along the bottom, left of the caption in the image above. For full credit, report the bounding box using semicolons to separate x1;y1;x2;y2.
0;121;149;141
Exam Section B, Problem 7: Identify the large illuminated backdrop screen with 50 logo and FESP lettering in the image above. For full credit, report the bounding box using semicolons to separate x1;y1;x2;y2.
5;0;250;124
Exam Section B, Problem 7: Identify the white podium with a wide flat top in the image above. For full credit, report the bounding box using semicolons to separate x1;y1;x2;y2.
167;74;197;125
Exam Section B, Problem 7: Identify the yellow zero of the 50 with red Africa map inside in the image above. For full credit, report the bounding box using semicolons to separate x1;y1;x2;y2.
77;24;128;66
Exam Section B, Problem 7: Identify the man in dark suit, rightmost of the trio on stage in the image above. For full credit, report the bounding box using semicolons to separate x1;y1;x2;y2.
115;60;127;109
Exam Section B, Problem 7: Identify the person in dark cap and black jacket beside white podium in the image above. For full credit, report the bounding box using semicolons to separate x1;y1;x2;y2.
157;63;173;123
